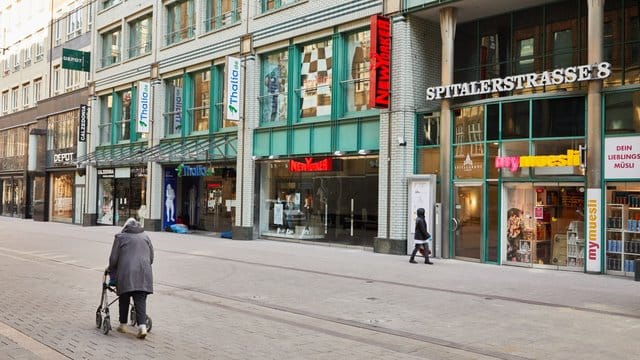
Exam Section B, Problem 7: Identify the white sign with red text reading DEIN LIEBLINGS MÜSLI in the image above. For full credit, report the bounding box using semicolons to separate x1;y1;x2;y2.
604;136;640;179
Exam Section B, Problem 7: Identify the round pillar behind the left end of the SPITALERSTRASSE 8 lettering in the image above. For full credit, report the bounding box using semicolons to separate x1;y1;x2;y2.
440;7;457;258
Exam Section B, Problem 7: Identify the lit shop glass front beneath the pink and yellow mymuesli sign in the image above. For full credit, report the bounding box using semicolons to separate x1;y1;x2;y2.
502;182;585;270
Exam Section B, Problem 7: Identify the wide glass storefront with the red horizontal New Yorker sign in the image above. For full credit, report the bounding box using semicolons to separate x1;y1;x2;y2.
257;156;378;246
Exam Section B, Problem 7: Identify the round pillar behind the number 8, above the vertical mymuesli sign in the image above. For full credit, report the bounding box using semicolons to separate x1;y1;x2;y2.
586;0;605;189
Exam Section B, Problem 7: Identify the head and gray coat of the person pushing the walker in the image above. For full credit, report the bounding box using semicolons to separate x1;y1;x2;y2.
109;221;153;295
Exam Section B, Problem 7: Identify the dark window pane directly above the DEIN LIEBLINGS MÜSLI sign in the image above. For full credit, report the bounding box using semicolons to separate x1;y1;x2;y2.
604;91;640;135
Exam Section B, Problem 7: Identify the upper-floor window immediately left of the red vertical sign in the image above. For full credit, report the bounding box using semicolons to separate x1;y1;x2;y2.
343;29;371;112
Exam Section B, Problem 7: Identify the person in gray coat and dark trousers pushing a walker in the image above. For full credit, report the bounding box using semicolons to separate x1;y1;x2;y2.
109;218;153;339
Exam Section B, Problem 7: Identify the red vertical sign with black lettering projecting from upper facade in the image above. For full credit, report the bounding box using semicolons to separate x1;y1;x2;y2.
369;15;391;109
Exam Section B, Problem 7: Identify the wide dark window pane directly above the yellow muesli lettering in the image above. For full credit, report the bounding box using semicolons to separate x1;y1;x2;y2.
532;97;586;138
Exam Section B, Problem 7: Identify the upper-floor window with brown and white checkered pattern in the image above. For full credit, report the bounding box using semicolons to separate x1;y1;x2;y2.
299;40;333;118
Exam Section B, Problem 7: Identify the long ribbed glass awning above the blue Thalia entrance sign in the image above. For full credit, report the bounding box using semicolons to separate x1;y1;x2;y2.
77;133;238;167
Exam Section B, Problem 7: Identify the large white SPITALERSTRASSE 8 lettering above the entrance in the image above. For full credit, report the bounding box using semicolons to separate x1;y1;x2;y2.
427;62;611;100
